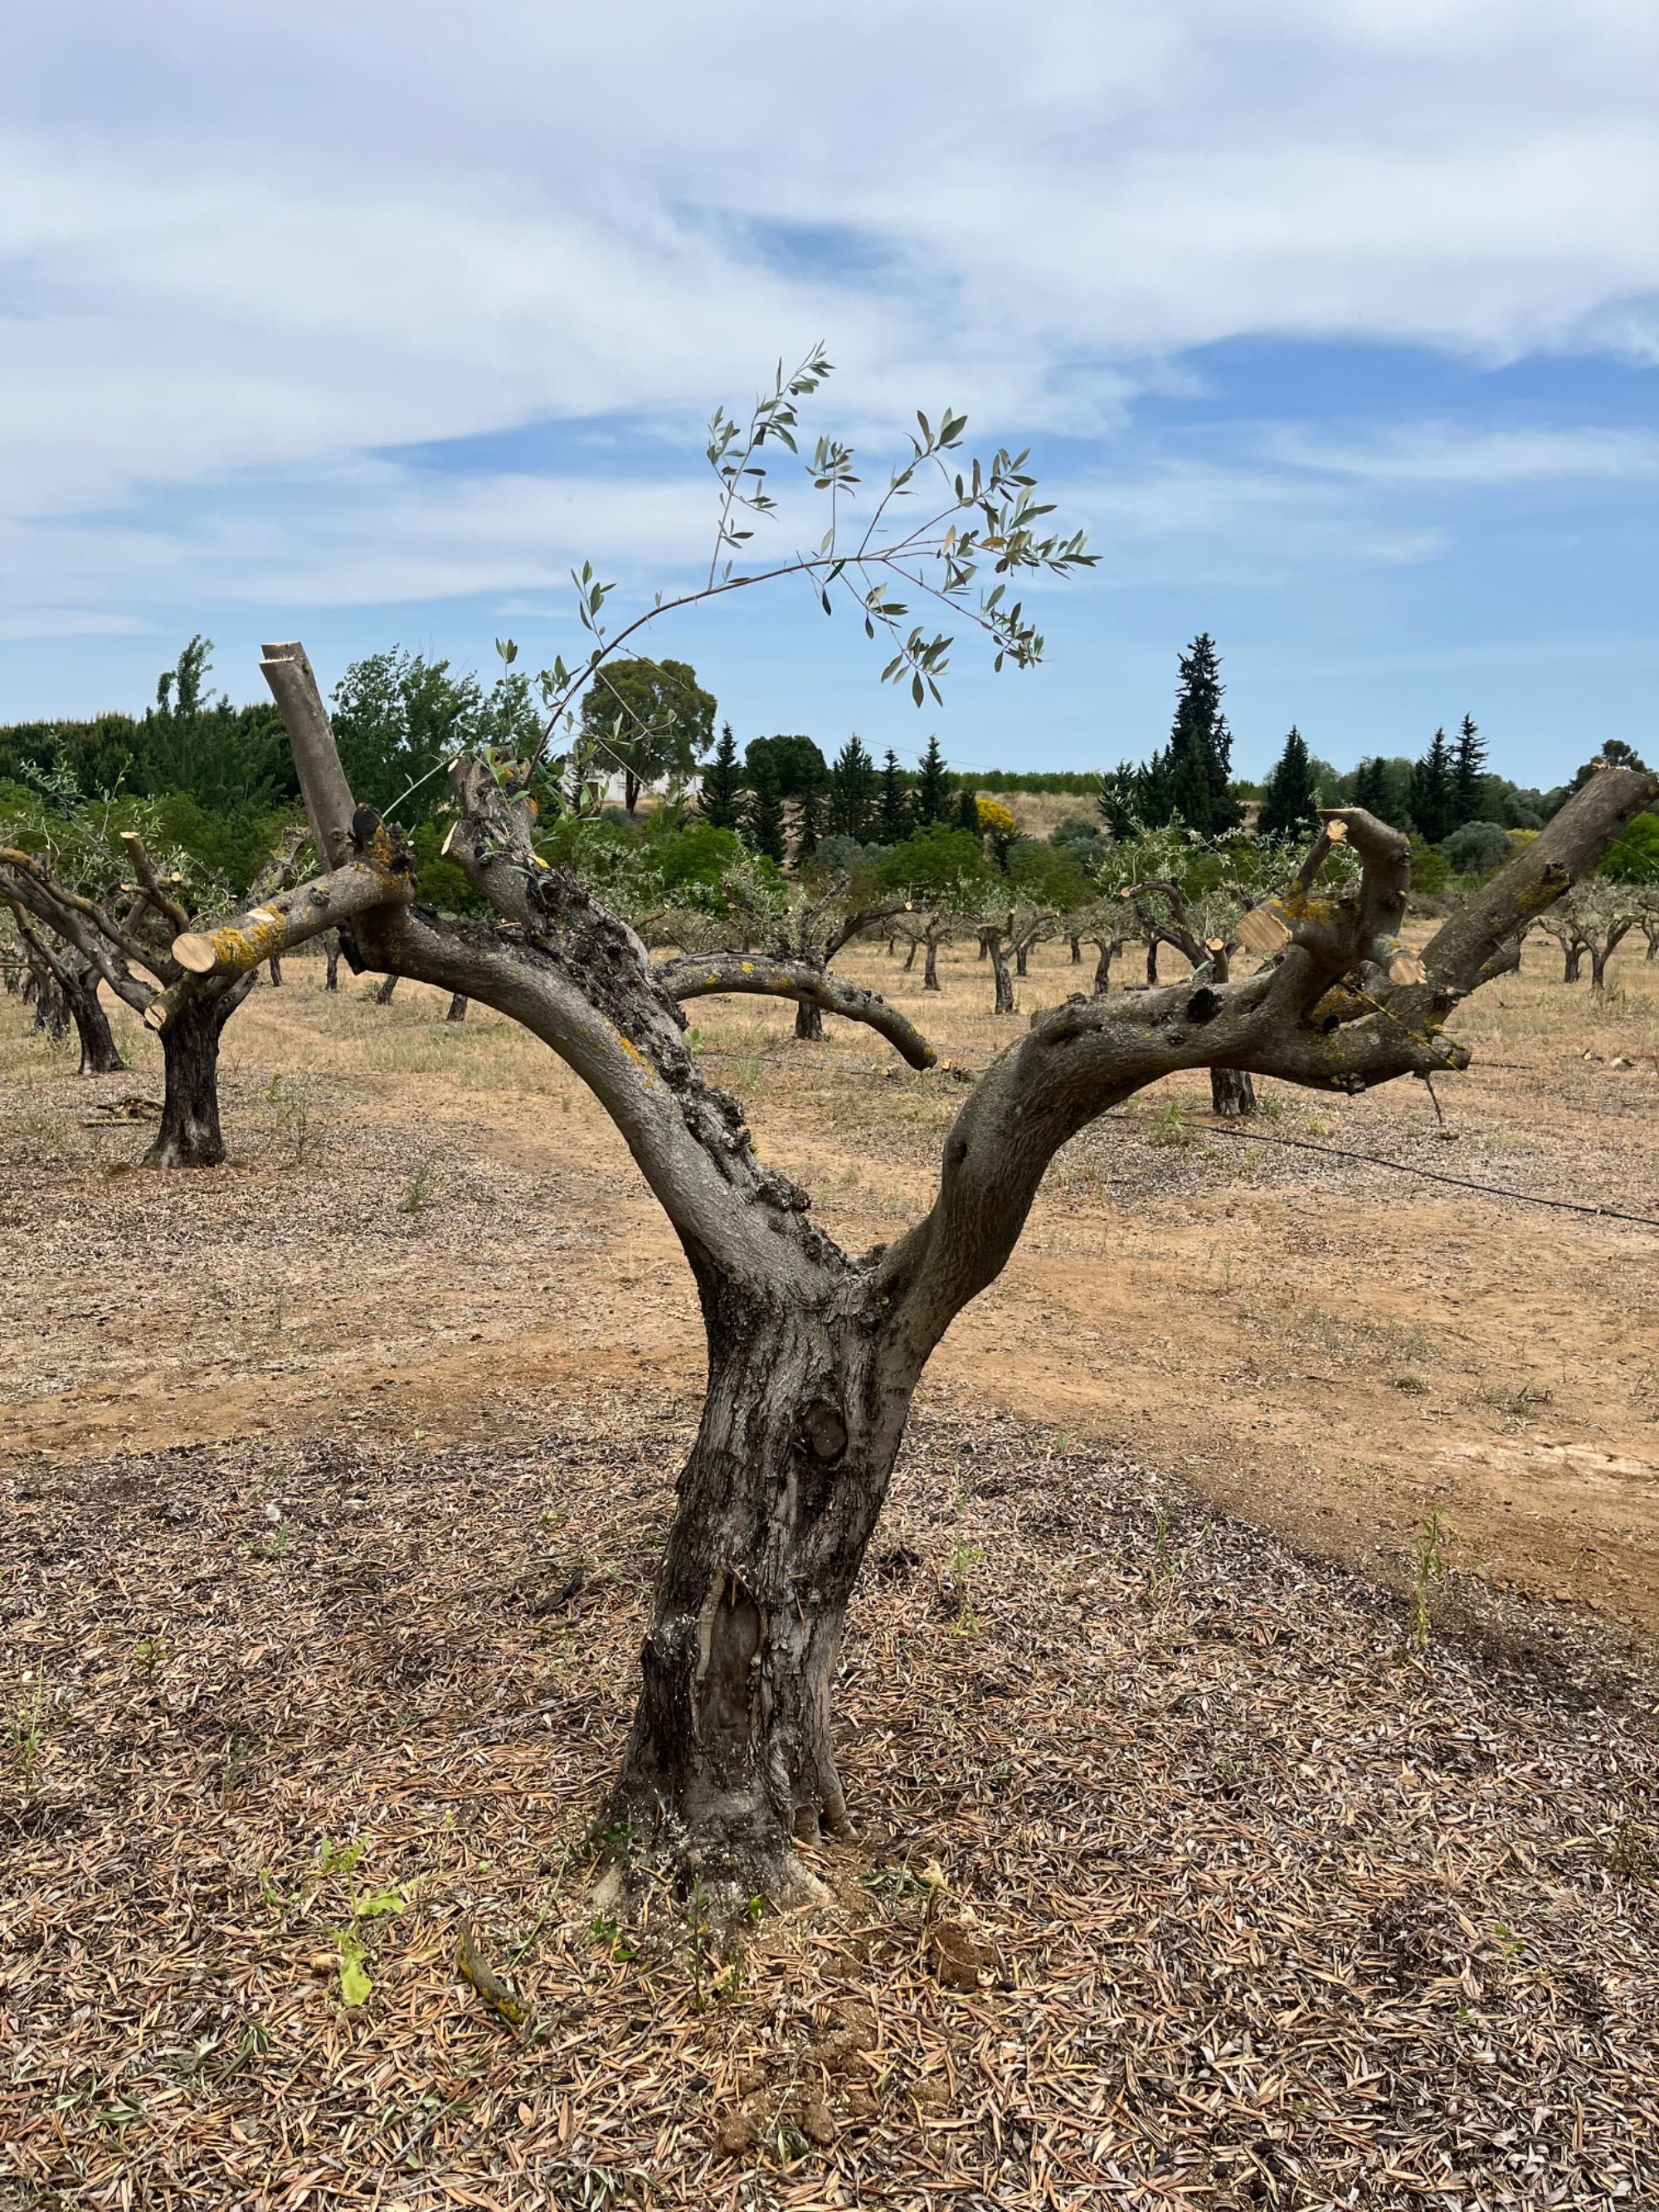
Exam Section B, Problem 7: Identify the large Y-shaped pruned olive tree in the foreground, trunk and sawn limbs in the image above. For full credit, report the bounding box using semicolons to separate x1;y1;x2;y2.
163;367;1655;1903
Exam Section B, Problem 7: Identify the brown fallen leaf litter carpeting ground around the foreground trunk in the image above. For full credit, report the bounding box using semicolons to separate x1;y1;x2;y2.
0;1383;1659;2212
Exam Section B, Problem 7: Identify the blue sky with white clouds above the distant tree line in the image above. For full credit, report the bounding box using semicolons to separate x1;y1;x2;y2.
0;0;1659;783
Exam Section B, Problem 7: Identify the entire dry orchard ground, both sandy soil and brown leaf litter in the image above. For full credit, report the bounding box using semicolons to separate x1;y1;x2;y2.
0;949;1659;2212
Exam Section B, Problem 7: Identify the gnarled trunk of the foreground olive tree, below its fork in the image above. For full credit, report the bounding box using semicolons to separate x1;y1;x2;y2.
611;1290;916;1898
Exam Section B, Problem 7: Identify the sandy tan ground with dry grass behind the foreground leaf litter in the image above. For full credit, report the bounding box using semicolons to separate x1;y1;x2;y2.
0;920;1659;1632
